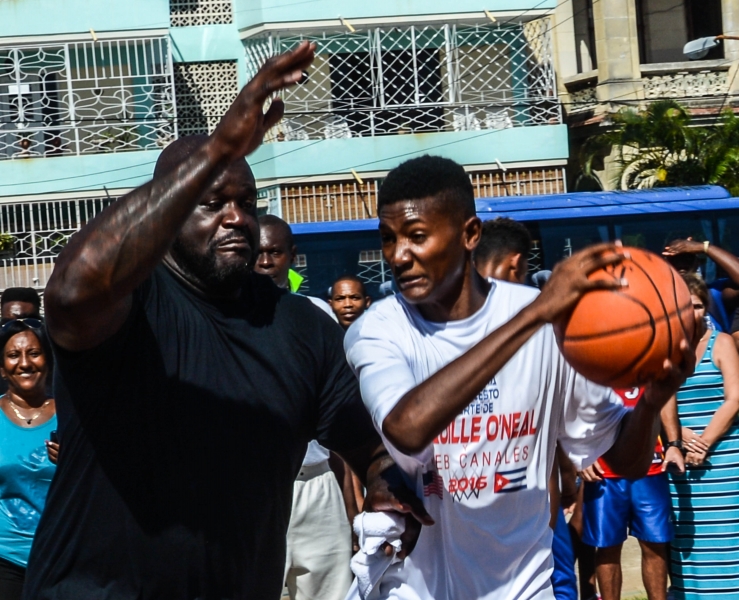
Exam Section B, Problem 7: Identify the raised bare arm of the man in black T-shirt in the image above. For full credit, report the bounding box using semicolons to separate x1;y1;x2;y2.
44;42;315;350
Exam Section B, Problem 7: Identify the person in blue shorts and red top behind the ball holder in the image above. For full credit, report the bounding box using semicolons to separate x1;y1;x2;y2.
581;388;685;600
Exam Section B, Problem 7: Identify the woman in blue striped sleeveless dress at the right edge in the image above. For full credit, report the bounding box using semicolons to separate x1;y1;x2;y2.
670;274;739;600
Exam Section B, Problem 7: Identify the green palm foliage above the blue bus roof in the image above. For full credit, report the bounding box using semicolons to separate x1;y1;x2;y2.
576;100;739;196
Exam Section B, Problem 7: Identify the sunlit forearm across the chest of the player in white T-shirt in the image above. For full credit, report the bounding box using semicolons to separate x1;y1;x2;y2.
382;302;545;454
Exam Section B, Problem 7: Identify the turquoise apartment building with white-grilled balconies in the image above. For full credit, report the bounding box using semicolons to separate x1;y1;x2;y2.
0;0;568;289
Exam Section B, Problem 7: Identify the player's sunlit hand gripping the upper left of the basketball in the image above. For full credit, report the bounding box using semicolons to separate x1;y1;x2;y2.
535;243;628;323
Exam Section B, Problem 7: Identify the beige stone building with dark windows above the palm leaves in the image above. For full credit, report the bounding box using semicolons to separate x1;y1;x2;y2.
553;0;739;186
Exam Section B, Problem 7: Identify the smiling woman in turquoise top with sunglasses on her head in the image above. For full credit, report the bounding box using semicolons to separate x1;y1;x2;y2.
0;318;57;600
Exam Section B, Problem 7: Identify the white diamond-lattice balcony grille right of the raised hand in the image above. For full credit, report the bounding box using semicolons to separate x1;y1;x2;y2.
245;18;562;141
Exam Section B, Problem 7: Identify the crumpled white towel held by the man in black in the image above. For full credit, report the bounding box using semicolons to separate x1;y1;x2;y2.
347;512;405;600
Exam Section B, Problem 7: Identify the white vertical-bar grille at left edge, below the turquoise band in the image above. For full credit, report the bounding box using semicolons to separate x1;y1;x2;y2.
0;197;116;289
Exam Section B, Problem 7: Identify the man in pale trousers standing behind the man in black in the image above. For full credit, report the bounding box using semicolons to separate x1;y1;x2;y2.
254;215;359;600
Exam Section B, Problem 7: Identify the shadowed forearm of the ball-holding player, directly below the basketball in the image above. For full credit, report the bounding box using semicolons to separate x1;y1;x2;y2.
603;401;660;479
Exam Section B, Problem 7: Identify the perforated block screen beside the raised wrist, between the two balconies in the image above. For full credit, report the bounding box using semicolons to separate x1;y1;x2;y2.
174;60;239;136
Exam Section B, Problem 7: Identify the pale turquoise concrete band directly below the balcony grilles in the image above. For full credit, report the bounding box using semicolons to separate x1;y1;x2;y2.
0;125;567;201
